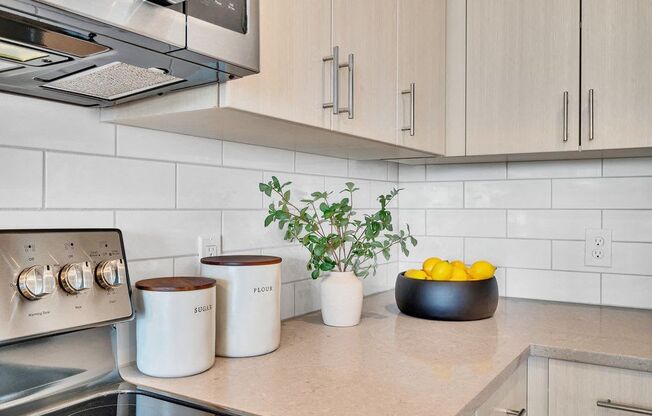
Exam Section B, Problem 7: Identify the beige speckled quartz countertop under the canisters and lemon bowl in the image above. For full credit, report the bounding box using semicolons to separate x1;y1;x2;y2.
121;291;652;416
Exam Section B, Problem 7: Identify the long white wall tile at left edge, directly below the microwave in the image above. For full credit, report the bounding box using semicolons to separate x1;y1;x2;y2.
0;93;115;155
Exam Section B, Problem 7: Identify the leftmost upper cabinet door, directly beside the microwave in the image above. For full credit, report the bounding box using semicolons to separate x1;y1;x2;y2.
220;0;331;128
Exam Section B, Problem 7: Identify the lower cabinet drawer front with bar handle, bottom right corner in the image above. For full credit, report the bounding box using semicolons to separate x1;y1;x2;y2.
548;360;652;416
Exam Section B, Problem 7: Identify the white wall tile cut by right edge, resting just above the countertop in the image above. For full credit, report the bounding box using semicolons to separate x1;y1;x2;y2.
602;274;652;309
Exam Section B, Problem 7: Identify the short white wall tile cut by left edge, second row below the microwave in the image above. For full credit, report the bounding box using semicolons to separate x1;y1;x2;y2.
0;149;43;208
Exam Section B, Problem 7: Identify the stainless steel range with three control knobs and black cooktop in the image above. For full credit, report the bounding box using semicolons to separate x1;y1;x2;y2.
0;229;238;416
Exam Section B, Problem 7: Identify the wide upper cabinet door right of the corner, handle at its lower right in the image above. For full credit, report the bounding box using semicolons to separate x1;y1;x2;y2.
466;0;580;155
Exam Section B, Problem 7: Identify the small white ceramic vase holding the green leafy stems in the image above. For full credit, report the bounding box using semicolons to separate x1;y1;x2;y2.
321;272;363;326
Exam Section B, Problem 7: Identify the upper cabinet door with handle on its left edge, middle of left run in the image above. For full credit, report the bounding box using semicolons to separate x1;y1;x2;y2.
332;0;396;144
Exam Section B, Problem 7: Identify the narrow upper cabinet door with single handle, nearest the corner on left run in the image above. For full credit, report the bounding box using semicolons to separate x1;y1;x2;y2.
397;0;446;154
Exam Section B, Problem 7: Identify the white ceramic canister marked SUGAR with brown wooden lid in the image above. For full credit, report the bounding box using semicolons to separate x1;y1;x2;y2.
136;277;216;377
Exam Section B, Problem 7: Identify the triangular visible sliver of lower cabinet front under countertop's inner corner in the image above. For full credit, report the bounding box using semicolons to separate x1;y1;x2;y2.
475;360;527;416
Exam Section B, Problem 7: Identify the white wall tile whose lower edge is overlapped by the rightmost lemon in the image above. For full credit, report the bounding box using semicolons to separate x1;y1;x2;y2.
464;238;551;269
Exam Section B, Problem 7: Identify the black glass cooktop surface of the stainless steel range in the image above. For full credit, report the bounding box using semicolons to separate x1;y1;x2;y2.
44;392;226;416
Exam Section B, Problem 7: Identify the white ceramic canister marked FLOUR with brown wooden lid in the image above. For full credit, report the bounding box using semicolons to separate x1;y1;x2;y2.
201;256;281;357
